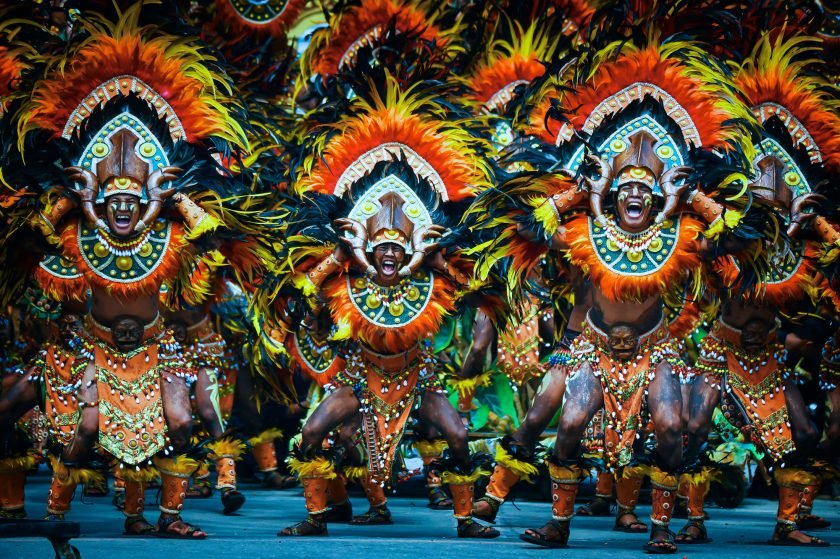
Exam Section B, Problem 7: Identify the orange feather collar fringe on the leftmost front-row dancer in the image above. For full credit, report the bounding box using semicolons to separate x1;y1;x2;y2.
61;219;186;299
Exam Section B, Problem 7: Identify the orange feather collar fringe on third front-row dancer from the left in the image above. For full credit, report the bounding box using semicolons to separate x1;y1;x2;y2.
564;215;705;301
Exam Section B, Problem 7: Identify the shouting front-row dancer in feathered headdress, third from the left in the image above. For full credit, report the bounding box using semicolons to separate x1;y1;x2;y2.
466;30;768;553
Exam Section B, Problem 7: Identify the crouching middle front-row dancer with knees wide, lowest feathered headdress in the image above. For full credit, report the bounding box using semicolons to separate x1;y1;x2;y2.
256;61;498;538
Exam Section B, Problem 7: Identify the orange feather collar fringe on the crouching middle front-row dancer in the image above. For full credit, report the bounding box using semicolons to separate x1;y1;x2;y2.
324;274;455;354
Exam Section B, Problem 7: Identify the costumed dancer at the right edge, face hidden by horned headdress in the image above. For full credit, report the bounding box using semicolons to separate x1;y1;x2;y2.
680;33;840;546
